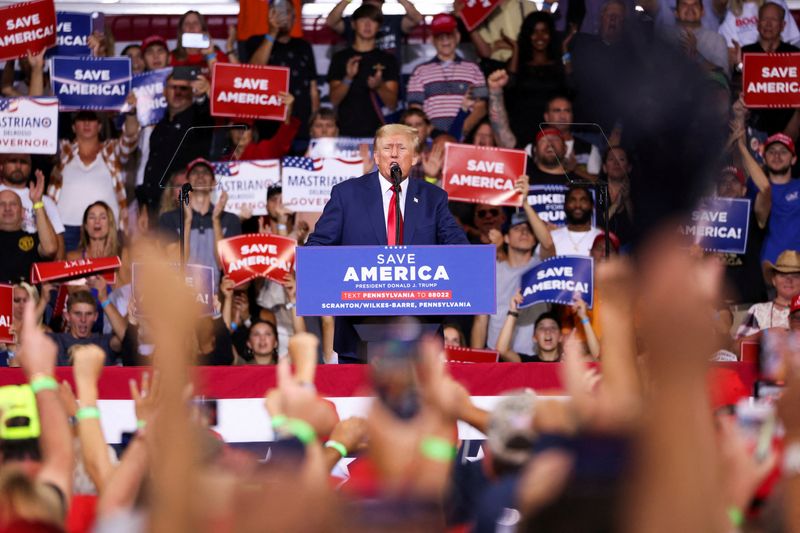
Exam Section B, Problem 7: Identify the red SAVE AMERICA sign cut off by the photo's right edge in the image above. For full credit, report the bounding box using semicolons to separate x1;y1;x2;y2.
742;53;800;107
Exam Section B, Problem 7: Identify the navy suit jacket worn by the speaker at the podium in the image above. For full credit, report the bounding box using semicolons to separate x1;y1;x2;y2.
306;171;469;360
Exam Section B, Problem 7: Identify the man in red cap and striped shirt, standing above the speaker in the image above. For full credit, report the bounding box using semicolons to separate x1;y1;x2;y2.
407;13;488;137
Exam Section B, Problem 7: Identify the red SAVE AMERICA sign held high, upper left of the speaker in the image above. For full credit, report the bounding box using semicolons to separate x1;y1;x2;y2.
211;63;289;120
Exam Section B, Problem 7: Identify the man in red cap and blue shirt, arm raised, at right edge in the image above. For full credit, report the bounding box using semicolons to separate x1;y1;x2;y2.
738;128;800;263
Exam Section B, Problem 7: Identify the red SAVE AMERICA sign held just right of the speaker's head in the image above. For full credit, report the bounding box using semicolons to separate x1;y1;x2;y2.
442;143;528;206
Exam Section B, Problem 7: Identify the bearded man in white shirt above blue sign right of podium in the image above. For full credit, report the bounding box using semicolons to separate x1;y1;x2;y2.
539;186;600;259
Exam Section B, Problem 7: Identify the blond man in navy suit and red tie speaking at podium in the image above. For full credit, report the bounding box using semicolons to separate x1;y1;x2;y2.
306;124;469;362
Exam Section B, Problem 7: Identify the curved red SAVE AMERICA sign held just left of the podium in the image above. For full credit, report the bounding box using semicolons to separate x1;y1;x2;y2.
217;233;297;285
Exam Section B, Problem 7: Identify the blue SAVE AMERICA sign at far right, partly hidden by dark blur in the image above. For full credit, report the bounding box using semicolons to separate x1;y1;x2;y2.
679;198;750;254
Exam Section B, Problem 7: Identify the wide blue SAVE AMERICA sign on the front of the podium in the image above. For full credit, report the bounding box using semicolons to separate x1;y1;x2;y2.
295;245;495;316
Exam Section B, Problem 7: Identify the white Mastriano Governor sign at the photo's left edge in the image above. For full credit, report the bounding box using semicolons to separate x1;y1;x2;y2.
0;96;58;154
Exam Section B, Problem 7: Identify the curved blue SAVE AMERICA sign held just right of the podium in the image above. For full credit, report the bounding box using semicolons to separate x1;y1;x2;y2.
519;255;594;309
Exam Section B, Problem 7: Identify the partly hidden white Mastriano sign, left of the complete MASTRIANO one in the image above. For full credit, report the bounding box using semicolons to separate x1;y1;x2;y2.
214;159;281;216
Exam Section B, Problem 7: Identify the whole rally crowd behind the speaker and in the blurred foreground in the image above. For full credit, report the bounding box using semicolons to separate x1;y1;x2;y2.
0;0;800;531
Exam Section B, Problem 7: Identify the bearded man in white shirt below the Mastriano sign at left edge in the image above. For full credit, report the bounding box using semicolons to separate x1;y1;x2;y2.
0;154;64;259
